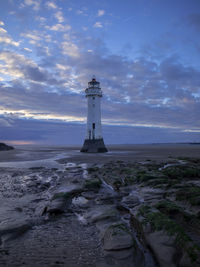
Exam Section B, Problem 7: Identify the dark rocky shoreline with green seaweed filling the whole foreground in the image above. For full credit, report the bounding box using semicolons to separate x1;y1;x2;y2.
0;158;200;267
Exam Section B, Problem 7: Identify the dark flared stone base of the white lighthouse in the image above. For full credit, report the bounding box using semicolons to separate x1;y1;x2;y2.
81;138;108;153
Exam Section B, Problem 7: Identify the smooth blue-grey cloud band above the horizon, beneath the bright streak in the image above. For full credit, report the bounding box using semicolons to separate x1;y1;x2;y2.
0;118;199;147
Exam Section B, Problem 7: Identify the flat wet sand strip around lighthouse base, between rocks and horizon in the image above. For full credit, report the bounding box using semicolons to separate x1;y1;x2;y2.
0;144;200;166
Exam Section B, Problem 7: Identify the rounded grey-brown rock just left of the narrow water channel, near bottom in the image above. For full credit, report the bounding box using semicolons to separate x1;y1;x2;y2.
103;223;134;250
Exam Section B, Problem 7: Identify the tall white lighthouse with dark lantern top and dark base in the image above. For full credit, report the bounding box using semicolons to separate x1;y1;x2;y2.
81;77;107;153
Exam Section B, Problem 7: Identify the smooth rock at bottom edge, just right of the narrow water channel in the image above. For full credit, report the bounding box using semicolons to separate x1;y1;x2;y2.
145;231;176;267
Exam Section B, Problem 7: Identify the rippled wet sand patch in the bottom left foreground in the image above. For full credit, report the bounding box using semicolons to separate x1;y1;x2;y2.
0;215;103;267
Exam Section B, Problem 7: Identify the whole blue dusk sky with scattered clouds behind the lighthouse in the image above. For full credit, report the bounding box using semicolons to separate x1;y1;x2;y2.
0;0;200;145
